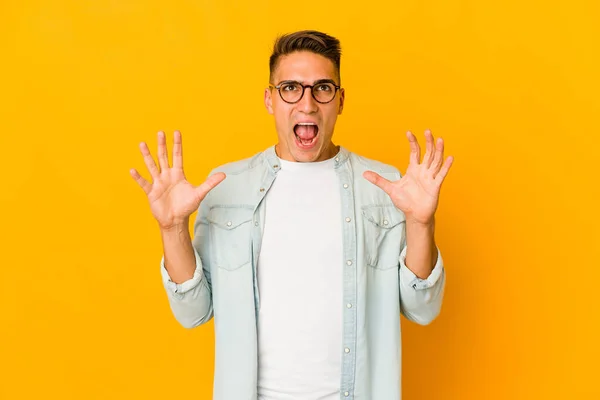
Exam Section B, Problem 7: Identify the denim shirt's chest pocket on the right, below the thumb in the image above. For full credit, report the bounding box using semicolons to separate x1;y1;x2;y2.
362;205;406;269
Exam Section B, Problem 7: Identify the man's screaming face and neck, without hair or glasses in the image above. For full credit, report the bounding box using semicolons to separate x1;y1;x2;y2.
265;51;344;162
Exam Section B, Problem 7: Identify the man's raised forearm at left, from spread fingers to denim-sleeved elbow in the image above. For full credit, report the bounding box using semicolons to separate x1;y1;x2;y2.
130;131;225;328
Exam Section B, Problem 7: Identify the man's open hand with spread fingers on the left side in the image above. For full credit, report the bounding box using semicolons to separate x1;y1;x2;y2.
130;131;225;231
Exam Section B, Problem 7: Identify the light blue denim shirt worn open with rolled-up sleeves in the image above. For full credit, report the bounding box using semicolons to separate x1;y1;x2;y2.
161;146;445;400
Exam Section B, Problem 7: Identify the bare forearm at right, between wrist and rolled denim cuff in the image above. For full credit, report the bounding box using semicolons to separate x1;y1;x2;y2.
406;220;437;279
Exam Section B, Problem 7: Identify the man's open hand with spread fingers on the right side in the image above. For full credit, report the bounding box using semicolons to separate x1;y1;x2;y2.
365;131;452;224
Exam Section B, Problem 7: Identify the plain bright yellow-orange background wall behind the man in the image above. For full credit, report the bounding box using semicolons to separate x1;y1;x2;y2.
0;0;600;400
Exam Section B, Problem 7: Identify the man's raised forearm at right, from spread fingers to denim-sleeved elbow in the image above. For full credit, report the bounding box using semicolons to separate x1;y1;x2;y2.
364;131;453;325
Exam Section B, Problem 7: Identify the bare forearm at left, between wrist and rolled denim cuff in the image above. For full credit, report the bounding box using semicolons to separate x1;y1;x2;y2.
160;220;196;283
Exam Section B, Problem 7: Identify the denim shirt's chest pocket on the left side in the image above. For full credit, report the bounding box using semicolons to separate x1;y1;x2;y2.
207;207;252;271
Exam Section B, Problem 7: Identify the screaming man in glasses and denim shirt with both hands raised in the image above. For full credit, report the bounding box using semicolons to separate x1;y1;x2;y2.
131;31;452;400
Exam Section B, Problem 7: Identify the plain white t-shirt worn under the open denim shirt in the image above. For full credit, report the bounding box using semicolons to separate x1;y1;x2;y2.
258;158;343;400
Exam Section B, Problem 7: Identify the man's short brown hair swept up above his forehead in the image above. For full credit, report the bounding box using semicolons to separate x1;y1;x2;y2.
269;30;342;85
